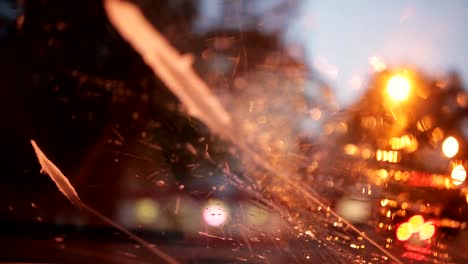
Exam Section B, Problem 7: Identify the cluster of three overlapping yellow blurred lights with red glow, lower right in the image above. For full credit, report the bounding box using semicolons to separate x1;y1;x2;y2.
396;215;435;241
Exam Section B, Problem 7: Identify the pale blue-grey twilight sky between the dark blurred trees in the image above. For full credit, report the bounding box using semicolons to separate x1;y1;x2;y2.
200;0;468;105
